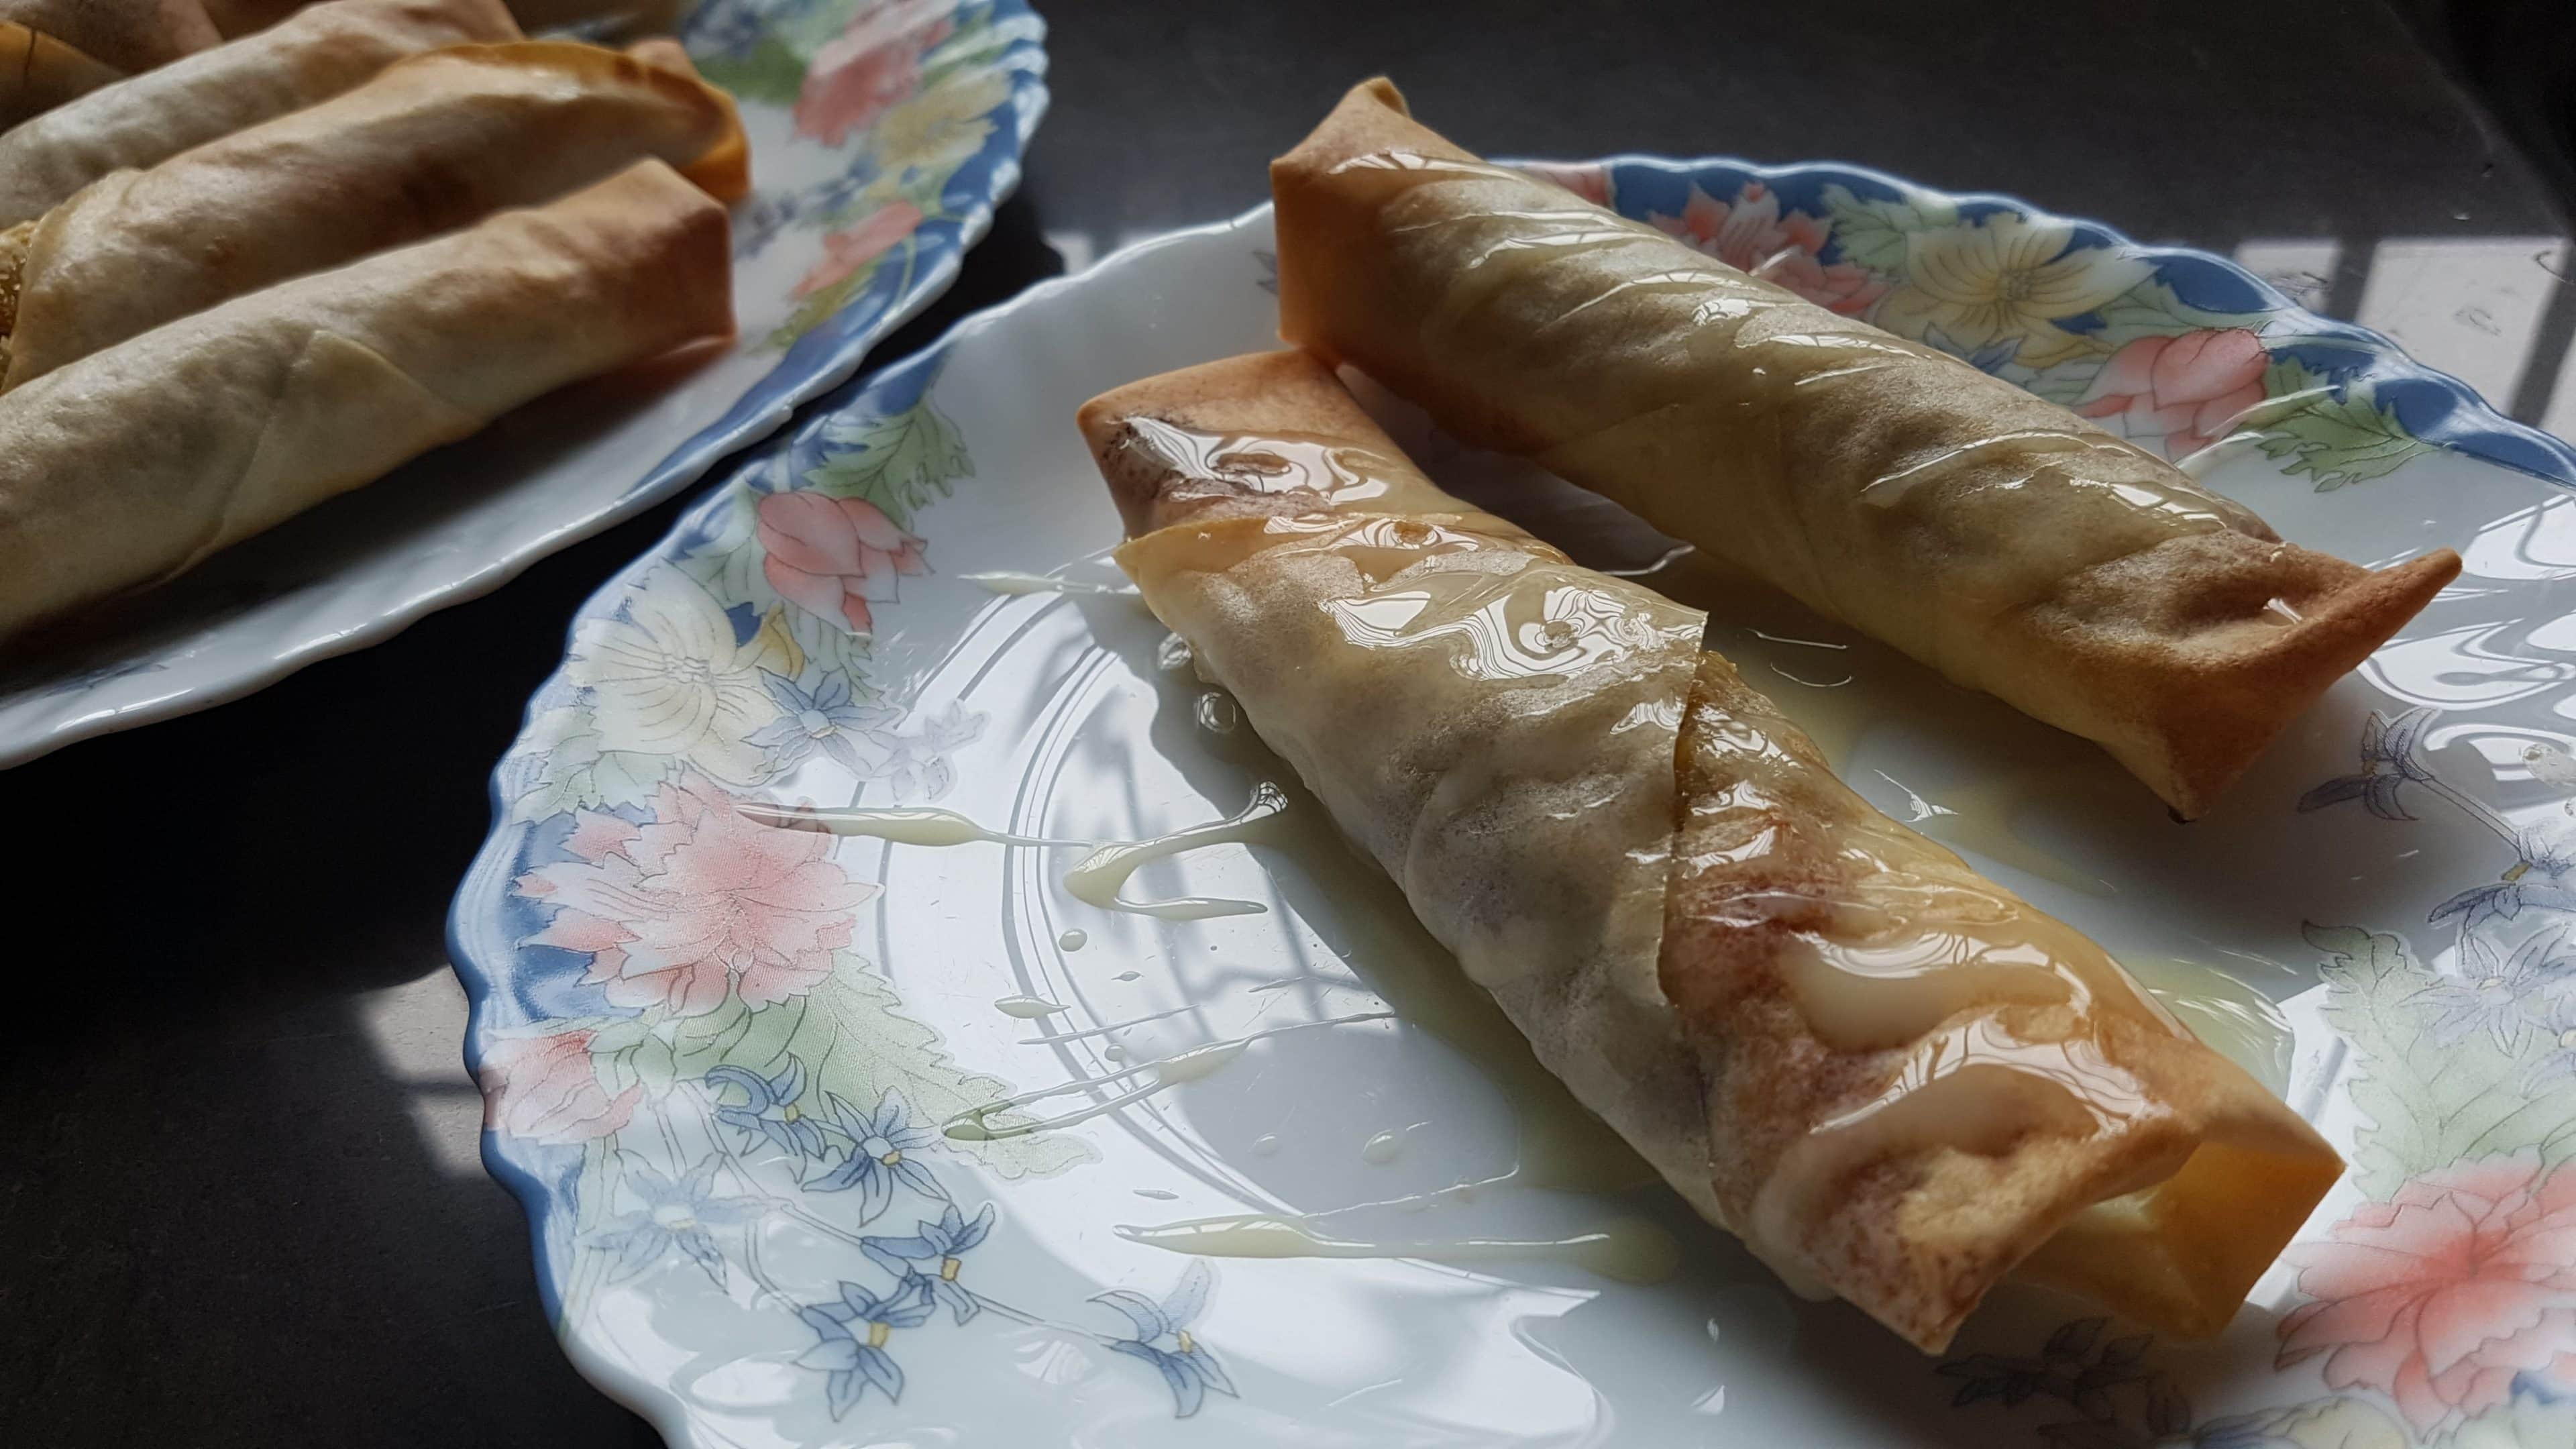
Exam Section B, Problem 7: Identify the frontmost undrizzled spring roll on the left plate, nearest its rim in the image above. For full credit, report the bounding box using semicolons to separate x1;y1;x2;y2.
0;160;732;637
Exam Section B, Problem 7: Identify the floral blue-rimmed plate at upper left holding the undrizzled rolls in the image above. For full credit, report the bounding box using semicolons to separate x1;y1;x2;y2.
0;0;1046;765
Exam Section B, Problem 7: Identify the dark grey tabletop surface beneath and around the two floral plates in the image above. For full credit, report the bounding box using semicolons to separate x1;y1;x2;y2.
0;0;2576;1449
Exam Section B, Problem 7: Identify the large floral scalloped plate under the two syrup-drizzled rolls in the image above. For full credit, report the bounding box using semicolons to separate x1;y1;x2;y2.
453;157;2576;1449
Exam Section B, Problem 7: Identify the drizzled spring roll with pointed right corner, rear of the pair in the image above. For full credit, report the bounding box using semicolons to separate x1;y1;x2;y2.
1270;80;2460;817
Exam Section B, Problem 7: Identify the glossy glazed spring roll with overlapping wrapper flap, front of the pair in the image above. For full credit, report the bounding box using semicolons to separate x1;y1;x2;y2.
1079;354;2342;1351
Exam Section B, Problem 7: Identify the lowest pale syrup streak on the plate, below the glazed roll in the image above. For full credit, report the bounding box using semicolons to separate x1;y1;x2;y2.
1118;1212;1682;1284
